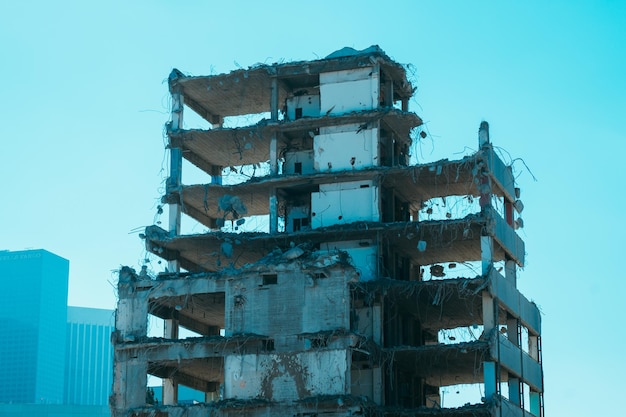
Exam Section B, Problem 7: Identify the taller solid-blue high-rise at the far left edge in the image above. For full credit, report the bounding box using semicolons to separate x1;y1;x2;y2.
0;249;69;404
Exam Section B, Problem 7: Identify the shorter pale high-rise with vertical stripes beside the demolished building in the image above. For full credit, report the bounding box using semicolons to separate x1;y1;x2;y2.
64;307;115;405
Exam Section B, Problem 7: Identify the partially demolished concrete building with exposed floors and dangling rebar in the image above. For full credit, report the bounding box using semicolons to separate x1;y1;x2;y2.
111;47;543;417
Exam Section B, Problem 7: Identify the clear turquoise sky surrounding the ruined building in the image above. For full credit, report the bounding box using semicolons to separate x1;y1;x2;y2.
0;0;626;416
